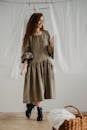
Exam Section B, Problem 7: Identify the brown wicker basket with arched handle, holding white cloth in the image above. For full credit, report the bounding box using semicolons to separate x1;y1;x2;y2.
52;105;87;130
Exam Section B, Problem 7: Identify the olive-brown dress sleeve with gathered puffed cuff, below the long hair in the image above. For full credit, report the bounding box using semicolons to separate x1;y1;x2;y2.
21;40;33;63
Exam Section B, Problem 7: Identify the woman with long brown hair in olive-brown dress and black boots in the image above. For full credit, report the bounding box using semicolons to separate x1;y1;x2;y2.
21;13;54;121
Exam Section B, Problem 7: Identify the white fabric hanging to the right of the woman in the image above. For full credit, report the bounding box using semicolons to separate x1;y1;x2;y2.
51;0;87;74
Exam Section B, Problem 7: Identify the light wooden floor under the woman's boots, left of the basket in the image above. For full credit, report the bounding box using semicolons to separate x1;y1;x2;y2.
0;112;51;130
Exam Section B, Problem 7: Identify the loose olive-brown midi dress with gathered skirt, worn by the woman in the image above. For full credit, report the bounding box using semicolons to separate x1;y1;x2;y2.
21;31;55;103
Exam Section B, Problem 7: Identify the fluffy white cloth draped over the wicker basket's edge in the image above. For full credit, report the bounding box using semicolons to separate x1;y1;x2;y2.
47;109;75;129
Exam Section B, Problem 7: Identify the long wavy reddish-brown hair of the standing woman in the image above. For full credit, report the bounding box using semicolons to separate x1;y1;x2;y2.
22;13;44;50
